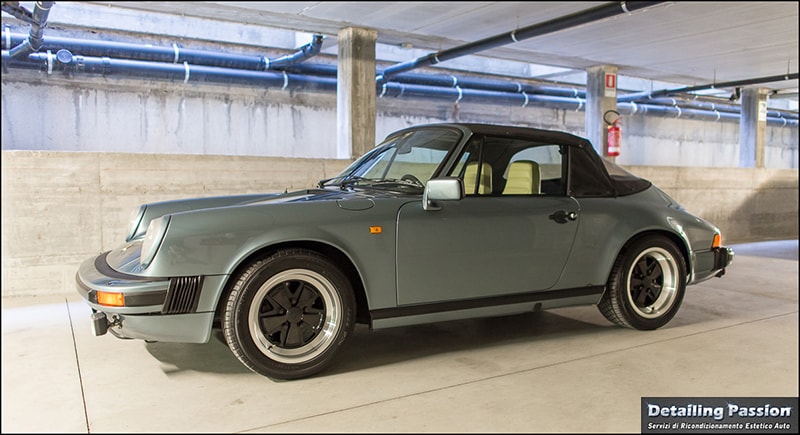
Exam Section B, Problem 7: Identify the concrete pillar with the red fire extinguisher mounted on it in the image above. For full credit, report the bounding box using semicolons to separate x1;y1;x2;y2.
584;65;625;161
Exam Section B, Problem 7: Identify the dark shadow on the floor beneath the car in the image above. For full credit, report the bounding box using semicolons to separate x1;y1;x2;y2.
145;311;620;377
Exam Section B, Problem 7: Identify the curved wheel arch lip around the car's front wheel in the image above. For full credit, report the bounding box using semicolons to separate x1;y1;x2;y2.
214;240;369;326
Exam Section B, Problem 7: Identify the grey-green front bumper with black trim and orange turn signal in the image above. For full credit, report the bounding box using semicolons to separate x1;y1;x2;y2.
75;253;221;343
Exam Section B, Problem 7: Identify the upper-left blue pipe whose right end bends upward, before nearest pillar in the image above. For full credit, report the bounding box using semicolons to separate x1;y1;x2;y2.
0;29;324;70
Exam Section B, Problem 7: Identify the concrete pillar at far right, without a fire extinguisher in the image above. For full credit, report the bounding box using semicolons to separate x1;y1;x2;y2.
739;88;767;168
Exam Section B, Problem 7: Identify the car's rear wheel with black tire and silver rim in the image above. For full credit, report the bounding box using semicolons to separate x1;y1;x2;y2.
598;236;686;330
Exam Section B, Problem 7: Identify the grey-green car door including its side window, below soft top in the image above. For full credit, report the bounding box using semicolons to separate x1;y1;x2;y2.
397;138;580;306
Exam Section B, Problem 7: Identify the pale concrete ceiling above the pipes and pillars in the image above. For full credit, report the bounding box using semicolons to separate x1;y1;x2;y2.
87;1;798;100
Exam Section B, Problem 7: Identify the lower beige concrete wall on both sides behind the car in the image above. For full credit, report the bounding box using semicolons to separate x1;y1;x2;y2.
2;151;798;296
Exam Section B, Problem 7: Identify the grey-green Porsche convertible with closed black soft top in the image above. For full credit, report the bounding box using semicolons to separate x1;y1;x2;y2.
76;123;734;379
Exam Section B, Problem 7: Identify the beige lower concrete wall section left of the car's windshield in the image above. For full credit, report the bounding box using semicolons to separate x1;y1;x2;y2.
2;151;349;296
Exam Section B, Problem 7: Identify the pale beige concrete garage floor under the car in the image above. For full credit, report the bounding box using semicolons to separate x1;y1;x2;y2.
2;240;798;433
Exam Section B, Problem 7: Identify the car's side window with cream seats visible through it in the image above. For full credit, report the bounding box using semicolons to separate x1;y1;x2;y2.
451;137;567;196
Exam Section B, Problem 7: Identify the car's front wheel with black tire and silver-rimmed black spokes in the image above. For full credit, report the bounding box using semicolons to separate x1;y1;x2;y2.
222;249;356;380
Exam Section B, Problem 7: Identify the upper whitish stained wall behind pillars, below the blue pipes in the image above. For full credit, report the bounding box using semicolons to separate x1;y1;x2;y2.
0;75;798;169
